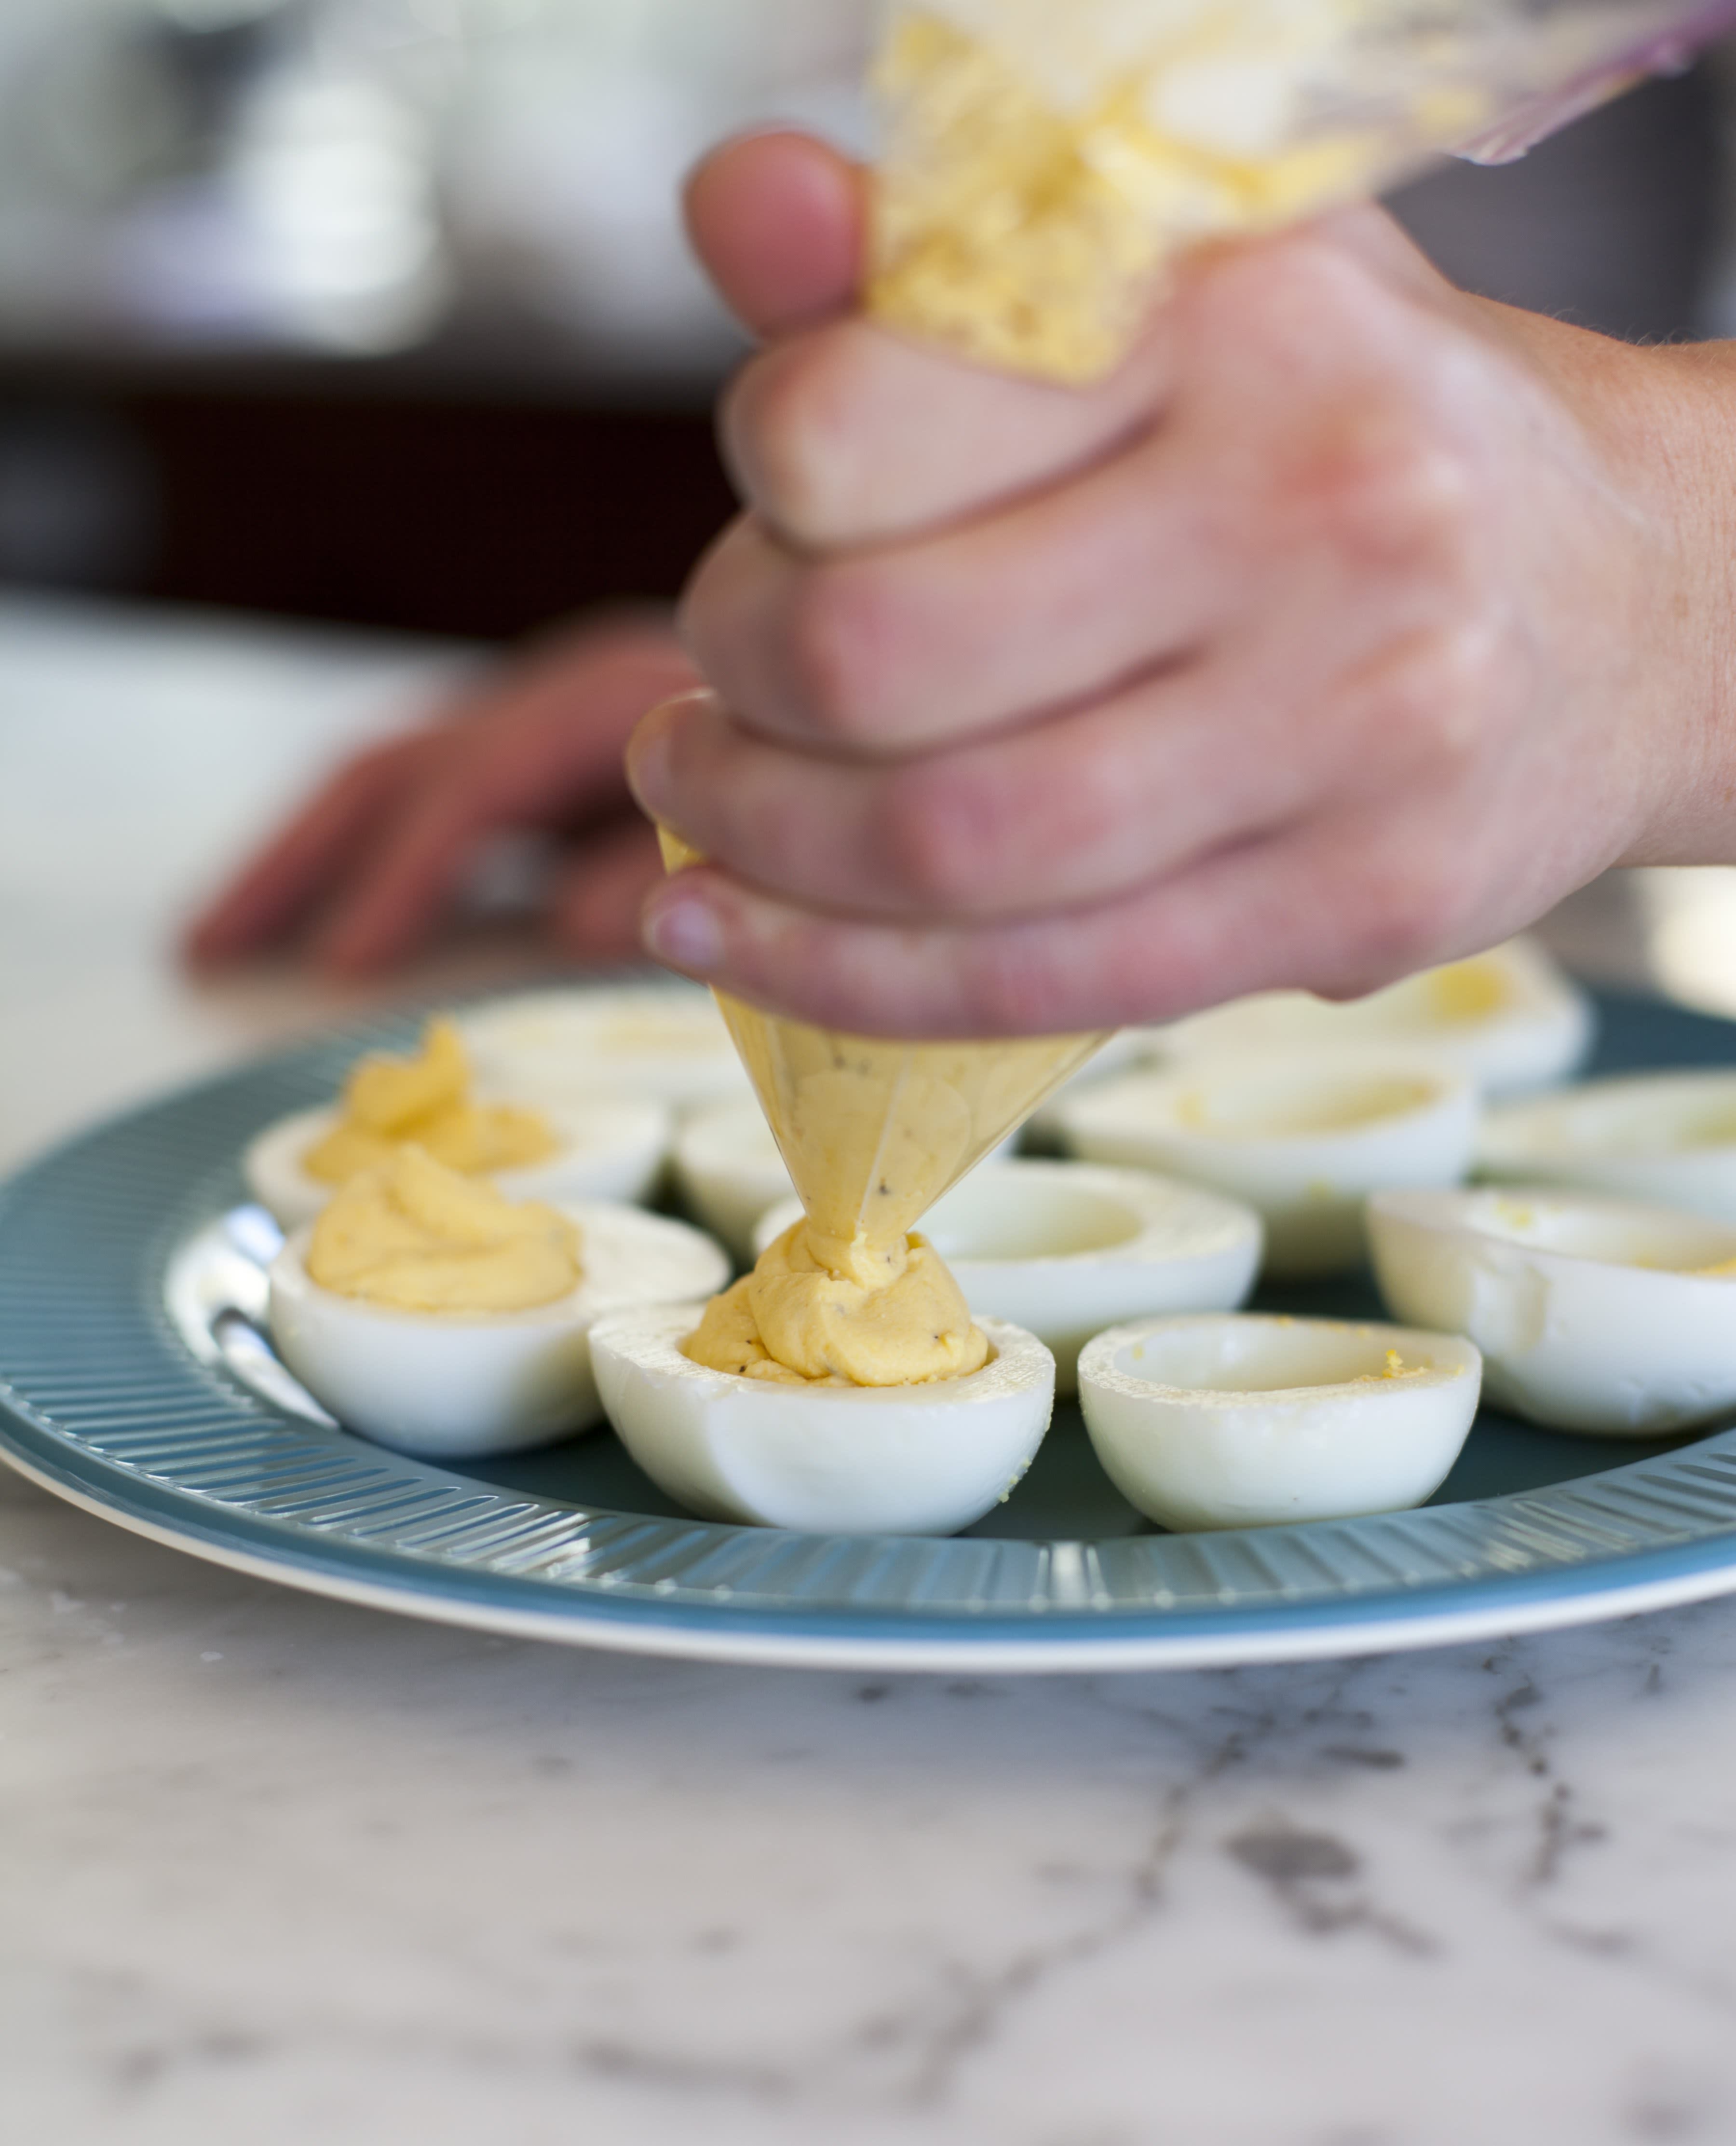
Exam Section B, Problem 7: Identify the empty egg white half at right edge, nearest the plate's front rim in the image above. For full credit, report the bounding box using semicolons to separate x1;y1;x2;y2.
1369;1187;1736;1438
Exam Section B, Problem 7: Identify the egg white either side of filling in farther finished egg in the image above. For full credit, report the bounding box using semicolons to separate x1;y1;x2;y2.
240;1094;672;1230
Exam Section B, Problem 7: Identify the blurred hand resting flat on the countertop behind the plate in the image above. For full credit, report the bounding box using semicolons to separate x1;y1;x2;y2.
187;618;693;976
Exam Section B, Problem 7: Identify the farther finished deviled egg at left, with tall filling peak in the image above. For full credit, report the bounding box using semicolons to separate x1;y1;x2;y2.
243;1017;672;1230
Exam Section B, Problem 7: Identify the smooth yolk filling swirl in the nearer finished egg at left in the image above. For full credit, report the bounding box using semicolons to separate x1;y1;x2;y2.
307;1146;583;1313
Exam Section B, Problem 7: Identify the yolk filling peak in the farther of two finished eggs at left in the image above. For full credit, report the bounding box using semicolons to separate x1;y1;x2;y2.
300;1019;560;1185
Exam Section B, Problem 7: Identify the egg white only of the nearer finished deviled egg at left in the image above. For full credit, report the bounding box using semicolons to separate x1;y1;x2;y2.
268;1202;730;1459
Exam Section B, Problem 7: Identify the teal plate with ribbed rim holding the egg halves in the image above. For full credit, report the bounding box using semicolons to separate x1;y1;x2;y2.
0;998;1736;1672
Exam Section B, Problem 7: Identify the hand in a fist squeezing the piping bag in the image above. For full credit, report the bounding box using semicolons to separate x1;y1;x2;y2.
629;137;1736;1037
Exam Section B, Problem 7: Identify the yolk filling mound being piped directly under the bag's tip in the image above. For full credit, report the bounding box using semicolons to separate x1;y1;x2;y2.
682;1221;989;1386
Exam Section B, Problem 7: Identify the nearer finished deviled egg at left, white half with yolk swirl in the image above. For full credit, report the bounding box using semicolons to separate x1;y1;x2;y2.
268;1146;730;1459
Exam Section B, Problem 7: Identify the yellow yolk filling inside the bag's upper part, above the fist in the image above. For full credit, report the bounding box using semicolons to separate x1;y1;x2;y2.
869;0;1493;382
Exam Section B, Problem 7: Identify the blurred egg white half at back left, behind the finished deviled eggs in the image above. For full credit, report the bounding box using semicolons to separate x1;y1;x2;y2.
457;983;751;1109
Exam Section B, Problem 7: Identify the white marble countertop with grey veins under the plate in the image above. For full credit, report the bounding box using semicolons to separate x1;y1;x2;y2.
0;603;1736;2146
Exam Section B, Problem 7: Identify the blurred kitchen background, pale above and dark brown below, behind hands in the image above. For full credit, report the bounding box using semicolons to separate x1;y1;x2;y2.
0;0;1736;637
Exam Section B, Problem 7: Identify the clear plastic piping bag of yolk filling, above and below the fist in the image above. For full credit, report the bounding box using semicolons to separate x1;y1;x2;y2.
663;0;1736;1249
